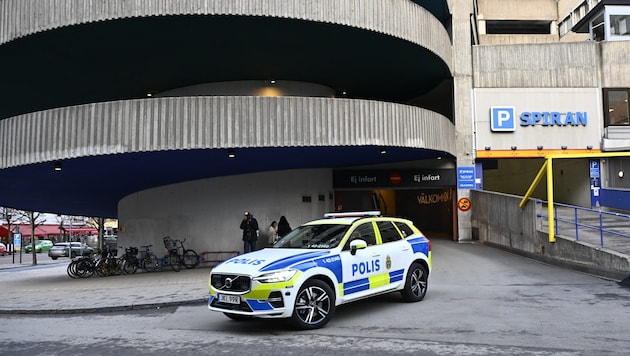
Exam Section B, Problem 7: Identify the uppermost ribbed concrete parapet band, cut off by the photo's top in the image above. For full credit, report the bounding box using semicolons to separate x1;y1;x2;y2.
0;0;451;71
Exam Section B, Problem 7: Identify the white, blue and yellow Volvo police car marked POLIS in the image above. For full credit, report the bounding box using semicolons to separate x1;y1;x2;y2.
208;211;431;329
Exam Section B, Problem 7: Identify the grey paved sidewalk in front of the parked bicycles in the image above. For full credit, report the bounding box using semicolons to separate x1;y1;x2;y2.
0;256;210;314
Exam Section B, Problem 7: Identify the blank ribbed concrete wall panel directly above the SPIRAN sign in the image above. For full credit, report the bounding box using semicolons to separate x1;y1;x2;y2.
473;42;604;88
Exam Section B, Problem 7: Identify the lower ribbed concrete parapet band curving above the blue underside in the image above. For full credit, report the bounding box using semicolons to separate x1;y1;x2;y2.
0;96;455;169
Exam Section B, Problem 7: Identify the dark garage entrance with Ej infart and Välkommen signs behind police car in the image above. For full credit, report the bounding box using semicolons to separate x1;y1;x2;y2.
333;169;457;240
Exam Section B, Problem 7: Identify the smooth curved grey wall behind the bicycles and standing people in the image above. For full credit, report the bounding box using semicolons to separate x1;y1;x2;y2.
118;169;334;256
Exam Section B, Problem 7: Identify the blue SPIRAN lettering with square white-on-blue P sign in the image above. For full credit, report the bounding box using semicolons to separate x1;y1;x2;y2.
490;106;588;132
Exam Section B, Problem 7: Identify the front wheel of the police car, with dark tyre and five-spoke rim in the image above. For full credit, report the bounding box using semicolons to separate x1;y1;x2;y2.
291;279;335;330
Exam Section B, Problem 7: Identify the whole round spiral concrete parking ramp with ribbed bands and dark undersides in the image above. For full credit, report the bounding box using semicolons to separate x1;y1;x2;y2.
0;0;456;245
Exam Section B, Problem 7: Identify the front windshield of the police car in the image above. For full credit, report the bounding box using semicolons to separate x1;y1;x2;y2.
273;224;350;249
